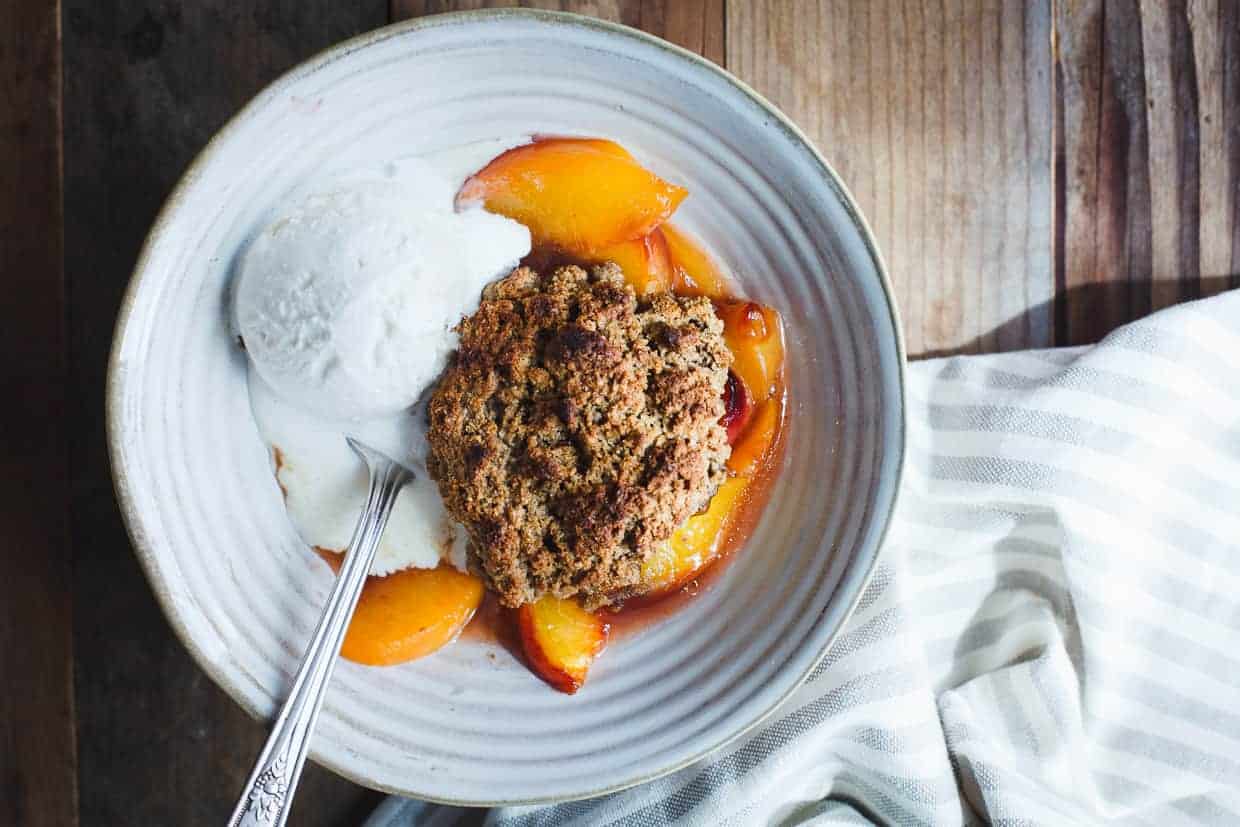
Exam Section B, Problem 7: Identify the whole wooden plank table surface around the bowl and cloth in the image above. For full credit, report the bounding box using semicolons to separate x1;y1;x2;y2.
0;0;1240;825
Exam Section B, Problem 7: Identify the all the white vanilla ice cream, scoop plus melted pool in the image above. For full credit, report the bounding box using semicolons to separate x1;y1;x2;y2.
233;140;529;574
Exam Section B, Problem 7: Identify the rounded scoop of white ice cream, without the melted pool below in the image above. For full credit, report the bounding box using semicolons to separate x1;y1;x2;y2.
234;160;529;419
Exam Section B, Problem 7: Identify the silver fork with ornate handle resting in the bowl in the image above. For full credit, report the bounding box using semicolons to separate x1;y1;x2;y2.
228;438;413;827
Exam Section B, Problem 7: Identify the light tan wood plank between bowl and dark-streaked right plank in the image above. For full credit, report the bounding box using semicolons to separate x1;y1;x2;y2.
727;0;1053;356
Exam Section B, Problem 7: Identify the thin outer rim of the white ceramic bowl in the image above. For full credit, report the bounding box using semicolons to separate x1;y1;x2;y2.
104;7;908;807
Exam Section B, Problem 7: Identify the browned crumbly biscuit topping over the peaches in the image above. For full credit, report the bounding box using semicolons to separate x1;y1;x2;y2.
428;264;732;608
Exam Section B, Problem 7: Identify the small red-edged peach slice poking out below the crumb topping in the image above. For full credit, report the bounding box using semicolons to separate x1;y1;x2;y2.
517;595;610;694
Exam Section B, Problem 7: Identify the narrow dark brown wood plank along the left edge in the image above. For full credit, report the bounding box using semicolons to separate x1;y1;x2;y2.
0;0;77;827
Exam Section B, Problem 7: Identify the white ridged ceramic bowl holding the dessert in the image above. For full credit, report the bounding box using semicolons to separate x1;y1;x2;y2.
108;11;904;805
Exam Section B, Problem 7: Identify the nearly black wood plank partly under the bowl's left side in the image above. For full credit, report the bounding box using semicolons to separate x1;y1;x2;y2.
59;0;387;825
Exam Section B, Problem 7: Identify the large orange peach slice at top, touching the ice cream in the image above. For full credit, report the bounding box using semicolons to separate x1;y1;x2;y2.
456;138;688;255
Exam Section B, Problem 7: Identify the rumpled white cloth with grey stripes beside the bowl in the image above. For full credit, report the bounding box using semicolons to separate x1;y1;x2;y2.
370;291;1240;827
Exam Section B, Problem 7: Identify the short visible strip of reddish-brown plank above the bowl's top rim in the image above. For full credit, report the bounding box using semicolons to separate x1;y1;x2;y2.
392;0;724;63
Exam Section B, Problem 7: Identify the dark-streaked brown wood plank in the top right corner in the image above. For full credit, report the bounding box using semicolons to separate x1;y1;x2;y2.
1055;0;1240;345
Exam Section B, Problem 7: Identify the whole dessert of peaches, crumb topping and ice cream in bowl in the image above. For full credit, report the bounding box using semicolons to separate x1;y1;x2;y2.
233;136;786;693
